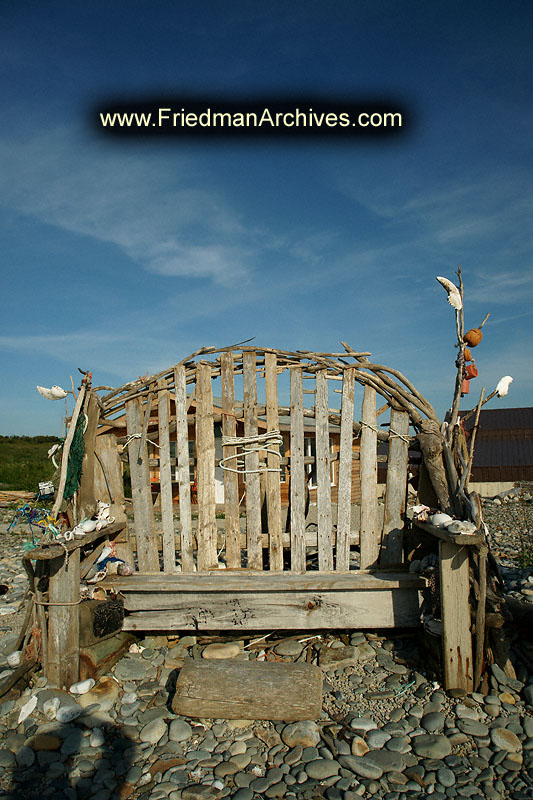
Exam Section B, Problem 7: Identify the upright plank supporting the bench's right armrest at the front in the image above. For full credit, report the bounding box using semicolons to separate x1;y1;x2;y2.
439;542;474;693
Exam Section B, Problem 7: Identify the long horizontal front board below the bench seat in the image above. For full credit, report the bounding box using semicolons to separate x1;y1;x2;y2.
124;588;420;630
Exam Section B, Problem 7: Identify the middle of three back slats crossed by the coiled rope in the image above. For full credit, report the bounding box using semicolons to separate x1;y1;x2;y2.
243;352;263;569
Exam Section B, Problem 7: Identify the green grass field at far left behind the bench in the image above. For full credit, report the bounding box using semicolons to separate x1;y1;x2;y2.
0;436;58;492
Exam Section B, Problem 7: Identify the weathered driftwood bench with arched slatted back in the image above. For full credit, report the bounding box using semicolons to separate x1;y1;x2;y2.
25;346;478;690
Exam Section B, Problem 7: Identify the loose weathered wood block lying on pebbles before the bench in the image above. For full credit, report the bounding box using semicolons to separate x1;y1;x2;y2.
172;659;322;722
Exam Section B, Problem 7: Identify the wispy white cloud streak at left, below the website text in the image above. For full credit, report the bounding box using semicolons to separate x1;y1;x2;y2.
0;130;257;285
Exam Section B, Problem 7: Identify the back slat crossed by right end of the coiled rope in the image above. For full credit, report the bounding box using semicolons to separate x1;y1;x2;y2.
265;353;283;571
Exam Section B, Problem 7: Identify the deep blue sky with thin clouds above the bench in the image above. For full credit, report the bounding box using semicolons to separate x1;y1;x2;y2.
0;0;533;434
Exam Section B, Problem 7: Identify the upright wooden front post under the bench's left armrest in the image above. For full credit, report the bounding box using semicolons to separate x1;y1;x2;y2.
46;548;80;689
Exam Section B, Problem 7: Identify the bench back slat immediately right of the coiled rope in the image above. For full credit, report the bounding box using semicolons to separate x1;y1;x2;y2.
290;367;305;572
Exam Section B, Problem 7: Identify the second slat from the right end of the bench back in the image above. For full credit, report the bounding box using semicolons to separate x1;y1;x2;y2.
360;386;380;569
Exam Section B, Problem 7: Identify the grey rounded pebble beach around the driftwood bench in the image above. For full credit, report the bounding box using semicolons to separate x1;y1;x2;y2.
0;492;533;800
